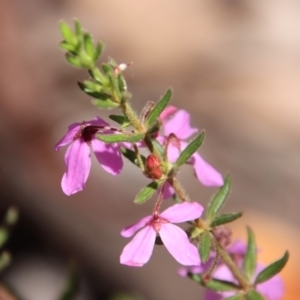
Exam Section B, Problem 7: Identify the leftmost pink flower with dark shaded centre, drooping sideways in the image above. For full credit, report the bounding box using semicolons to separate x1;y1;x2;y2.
55;117;123;196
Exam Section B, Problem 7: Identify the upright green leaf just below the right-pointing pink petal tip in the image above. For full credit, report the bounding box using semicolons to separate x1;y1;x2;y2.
206;175;231;223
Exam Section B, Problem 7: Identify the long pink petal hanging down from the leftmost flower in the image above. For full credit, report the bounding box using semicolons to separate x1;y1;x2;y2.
61;139;91;196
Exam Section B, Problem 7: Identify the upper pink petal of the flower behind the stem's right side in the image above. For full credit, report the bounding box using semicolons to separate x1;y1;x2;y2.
164;110;198;140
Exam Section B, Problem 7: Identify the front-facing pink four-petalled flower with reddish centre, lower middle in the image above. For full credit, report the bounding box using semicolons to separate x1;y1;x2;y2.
120;202;203;267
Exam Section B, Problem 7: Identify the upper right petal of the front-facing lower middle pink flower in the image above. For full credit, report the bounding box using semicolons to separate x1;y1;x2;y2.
160;202;203;223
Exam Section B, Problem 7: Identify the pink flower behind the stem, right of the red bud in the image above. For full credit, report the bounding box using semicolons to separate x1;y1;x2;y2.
158;106;224;186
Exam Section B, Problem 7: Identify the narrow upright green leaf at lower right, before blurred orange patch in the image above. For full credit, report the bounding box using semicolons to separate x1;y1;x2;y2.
243;227;257;282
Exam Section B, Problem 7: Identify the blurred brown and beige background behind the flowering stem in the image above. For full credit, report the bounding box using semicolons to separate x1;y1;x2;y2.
0;0;300;300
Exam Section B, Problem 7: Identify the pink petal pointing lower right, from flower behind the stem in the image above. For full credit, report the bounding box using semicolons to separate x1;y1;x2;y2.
191;152;224;186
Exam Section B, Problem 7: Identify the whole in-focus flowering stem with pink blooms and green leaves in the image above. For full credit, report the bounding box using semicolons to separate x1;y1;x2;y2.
55;21;289;300
